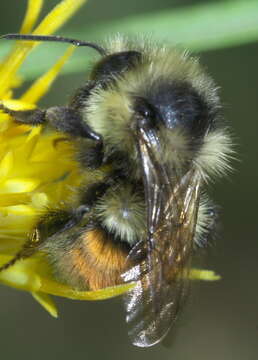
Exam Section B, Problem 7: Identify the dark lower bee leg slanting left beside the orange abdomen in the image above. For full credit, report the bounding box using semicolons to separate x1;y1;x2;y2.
0;205;90;272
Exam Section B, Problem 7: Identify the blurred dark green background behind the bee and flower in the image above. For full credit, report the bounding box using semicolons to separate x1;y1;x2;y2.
0;0;258;360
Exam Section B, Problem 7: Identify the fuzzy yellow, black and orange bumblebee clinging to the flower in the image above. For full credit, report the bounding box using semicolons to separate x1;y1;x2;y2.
0;34;231;347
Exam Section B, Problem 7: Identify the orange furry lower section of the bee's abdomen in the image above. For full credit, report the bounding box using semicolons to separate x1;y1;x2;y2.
55;229;127;290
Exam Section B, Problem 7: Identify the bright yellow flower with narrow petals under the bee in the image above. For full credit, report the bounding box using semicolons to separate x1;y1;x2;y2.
0;0;218;316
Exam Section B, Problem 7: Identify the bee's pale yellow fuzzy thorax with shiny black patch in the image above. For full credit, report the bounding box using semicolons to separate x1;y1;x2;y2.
83;39;230;181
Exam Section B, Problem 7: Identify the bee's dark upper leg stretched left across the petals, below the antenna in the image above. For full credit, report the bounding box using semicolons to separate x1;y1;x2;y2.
0;104;102;144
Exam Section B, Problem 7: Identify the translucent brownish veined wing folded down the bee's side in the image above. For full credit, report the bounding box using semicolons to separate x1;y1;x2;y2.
123;126;200;347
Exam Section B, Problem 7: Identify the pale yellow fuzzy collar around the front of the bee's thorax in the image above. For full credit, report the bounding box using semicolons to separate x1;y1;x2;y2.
83;36;220;167
